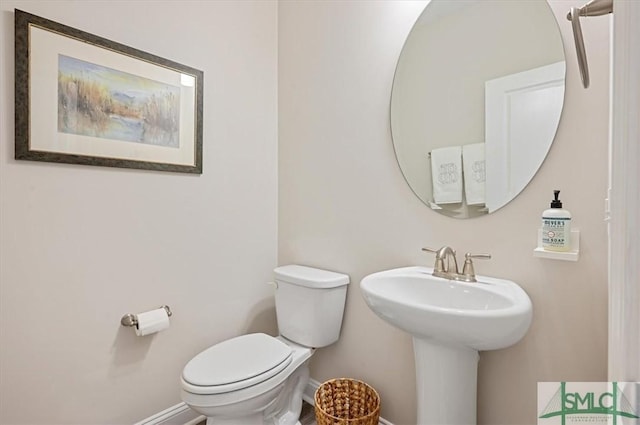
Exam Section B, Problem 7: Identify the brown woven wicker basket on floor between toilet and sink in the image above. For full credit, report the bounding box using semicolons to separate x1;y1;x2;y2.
314;378;380;425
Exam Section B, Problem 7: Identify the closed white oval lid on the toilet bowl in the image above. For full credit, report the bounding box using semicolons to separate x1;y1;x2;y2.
182;333;291;389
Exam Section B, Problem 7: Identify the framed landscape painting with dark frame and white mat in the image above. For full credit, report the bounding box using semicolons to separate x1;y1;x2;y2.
15;10;203;174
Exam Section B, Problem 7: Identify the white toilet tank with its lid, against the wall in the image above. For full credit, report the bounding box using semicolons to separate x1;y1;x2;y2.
274;265;349;348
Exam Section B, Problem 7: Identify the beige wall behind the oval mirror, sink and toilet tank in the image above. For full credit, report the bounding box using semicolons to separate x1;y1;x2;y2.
278;0;609;425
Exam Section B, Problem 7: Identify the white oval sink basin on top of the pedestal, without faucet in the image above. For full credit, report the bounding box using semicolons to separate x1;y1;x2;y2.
360;267;532;350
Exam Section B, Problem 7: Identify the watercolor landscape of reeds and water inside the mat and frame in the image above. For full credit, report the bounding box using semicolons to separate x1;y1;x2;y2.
58;55;180;148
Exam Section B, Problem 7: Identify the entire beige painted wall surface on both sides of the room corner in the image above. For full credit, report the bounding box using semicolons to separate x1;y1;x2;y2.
0;0;609;425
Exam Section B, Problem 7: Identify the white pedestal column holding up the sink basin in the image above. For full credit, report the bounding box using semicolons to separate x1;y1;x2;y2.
413;337;479;425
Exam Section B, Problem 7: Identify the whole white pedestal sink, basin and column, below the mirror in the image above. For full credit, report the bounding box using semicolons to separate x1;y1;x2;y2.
360;267;532;425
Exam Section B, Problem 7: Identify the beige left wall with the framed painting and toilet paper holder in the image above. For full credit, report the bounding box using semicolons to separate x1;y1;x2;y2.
0;0;277;424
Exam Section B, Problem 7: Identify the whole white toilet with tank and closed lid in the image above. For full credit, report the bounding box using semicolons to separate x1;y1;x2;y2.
181;265;349;425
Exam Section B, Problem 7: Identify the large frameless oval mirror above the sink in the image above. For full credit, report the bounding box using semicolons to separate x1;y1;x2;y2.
391;0;565;218
